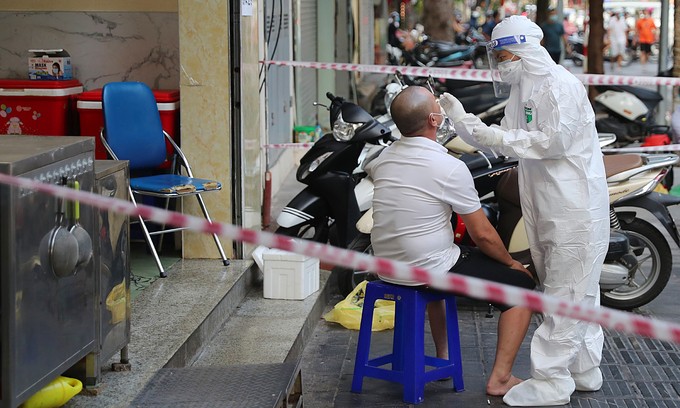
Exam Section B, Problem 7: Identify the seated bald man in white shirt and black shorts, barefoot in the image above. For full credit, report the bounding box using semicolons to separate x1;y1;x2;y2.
366;86;535;396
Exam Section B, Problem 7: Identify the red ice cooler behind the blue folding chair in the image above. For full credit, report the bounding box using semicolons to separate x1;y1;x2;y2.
77;89;179;160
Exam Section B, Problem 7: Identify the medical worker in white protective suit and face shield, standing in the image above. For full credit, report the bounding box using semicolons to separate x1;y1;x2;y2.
440;16;609;406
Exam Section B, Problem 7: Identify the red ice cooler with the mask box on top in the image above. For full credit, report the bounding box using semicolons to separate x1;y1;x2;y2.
0;79;83;136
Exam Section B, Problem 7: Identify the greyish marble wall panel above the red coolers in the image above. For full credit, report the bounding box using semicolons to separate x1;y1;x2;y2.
0;12;180;90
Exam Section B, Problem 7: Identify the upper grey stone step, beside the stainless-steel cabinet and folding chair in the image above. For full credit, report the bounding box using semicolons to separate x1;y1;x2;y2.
66;259;259;407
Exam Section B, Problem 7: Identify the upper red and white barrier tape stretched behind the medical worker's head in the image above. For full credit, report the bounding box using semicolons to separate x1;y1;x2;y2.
260;60;680;86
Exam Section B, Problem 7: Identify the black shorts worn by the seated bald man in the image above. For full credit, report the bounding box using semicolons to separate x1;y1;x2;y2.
449;246;536;312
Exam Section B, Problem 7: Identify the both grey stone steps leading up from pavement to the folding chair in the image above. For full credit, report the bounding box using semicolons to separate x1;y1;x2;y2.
66;260;332;408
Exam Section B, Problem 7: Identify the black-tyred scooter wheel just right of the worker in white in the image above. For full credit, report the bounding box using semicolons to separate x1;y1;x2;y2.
601;218;673;310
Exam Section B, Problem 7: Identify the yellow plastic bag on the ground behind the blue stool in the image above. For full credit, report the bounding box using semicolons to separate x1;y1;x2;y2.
323;281;394;331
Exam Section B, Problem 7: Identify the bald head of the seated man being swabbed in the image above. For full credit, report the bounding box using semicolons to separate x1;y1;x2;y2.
390;86;439;136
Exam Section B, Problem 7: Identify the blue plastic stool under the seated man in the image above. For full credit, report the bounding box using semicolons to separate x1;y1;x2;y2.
352;281;465;404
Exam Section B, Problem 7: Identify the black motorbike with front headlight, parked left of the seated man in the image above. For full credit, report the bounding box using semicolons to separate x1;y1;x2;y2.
275;93;395;247
